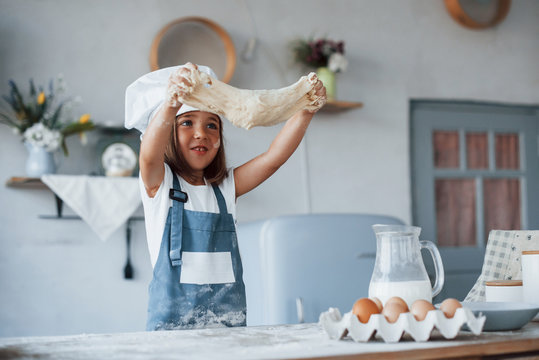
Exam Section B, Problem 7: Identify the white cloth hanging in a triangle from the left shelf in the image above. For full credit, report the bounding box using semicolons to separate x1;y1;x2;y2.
41;175;141;241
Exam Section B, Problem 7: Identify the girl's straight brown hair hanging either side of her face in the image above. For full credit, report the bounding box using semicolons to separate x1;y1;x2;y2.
165;117;228;185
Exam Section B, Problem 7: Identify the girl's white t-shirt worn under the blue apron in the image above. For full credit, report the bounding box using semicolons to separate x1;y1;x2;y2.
139;164;236;267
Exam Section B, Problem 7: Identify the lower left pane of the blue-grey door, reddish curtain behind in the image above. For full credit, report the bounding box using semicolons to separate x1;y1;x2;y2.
436;179;476;246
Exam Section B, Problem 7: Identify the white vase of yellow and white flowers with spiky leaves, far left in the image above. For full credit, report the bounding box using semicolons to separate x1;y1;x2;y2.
0;76;95;177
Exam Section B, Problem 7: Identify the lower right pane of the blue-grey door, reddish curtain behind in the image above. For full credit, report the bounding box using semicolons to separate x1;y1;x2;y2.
483;179;520;234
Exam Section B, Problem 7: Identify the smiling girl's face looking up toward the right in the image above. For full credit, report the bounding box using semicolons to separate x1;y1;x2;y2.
176;111;221;175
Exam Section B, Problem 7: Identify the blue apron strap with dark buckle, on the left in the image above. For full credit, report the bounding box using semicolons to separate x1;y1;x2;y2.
169;173;187;266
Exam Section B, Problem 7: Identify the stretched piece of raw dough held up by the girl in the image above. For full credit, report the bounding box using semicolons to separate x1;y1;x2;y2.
175;66;326;130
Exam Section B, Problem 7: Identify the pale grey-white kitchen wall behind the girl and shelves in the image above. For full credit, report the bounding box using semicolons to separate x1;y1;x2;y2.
0;0;539;336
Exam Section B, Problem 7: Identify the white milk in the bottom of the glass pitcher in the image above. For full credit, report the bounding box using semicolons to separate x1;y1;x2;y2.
369;280;432;307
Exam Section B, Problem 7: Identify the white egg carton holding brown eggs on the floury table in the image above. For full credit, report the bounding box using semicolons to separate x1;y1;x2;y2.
318;308;486;343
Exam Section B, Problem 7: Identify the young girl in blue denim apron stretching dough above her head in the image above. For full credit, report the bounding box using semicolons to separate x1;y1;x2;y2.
128;64;325;330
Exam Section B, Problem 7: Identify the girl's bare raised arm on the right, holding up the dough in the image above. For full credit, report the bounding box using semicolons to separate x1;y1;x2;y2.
234;80;326;198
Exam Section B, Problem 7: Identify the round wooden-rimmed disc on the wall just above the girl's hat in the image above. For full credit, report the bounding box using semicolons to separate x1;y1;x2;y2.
150;16;236;83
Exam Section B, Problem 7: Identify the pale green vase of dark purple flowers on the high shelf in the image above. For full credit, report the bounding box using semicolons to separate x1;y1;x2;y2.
292;39;348;100
